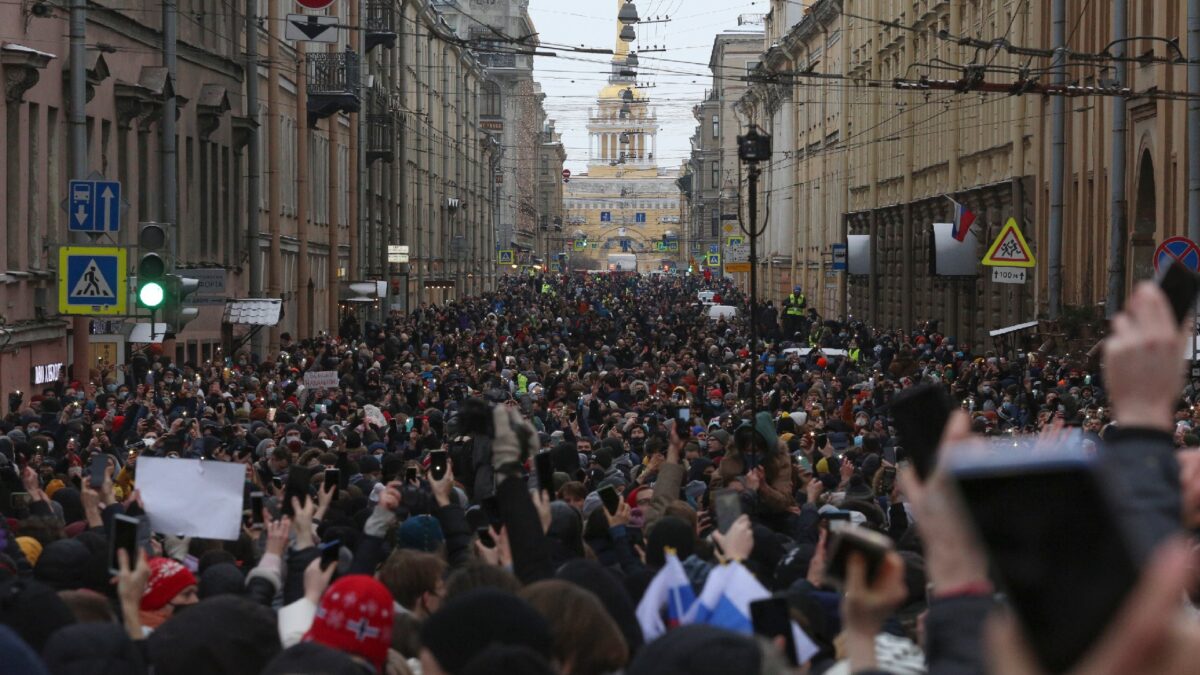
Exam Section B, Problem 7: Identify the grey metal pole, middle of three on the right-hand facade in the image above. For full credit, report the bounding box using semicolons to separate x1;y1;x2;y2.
1104;0;1123;318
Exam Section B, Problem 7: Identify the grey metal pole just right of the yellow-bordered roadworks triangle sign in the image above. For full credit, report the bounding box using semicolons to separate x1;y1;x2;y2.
1046;0;1067;321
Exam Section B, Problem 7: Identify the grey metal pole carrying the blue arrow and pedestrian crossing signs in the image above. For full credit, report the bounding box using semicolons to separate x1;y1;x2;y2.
68;0;91;382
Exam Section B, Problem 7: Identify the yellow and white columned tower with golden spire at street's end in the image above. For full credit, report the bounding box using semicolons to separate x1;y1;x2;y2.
588;0;659;178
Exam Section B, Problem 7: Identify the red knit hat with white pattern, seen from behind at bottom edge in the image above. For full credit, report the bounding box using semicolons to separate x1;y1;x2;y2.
304;574;392;670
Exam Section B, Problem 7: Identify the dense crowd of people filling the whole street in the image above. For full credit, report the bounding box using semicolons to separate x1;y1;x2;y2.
0;269;1200;675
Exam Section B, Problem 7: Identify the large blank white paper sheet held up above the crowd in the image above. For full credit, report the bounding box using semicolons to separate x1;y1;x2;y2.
137;458;246;540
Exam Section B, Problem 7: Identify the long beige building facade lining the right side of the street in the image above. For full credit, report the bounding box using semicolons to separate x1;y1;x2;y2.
715;0;1188;344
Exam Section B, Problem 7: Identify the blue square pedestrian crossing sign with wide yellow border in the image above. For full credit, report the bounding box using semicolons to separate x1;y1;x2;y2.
59;246;128;316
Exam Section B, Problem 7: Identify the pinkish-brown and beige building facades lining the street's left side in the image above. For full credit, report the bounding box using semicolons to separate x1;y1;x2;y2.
0;0;499;390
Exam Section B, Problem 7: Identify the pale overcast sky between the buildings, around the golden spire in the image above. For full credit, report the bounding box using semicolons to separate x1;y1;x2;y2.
529;0;769;173
